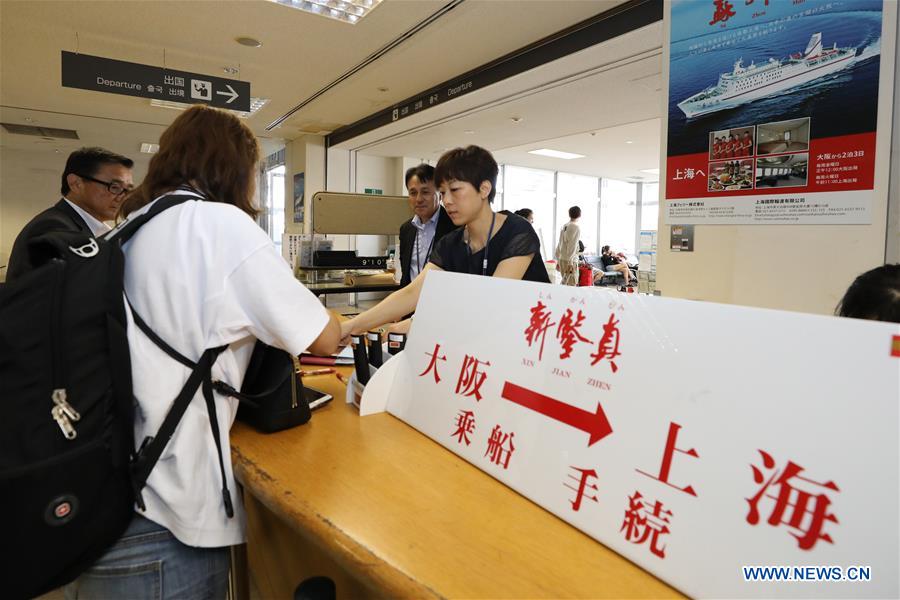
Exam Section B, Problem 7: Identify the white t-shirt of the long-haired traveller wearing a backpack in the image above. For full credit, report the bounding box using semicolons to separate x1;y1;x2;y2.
113;192;328;547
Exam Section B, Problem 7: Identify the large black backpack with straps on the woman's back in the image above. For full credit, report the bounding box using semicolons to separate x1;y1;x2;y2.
0;192;234;598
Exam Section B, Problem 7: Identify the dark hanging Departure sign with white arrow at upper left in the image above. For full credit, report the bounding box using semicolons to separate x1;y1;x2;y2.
62;51;250;112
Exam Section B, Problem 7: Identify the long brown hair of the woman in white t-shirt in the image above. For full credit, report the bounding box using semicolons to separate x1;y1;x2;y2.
119;105;259;217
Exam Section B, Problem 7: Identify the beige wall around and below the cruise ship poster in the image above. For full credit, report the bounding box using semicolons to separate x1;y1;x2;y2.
657;2;900;314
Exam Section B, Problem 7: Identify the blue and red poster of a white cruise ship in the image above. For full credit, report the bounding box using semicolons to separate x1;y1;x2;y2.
666;0;883;225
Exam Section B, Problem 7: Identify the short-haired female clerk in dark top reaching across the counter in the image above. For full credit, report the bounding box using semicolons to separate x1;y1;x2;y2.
341;146;550;338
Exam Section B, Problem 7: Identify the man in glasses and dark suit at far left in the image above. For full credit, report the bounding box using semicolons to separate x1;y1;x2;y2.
6;148;134;281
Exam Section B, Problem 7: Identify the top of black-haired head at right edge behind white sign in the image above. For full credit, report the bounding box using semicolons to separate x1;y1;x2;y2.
835;264;900;323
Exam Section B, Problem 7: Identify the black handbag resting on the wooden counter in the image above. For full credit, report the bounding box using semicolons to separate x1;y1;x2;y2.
213;340;311;433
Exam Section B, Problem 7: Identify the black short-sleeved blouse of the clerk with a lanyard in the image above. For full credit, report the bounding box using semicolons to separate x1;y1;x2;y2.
428;210;550;283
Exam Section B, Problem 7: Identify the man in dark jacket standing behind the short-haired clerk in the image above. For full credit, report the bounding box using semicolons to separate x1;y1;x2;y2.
400;163;455;286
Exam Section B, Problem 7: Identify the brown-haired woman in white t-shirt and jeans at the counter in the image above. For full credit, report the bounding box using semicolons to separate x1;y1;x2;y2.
66;106;340;598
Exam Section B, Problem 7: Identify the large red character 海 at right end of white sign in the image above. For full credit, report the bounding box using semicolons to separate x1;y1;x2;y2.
746;450;840;550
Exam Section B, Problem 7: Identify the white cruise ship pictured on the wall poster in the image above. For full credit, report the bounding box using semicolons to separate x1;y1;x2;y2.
678;33;856;118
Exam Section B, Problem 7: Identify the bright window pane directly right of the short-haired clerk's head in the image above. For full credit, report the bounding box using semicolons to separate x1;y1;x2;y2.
495;165;556;259
